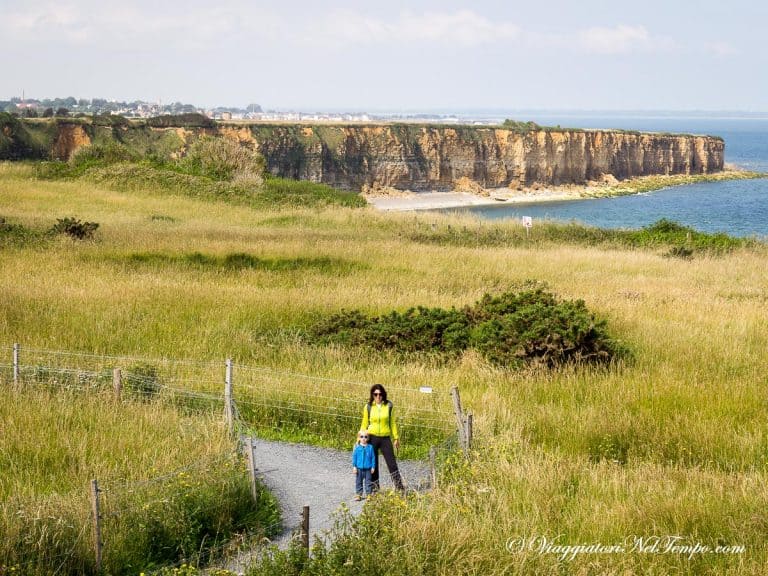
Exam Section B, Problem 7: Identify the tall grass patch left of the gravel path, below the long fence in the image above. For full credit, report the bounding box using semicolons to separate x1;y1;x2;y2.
0;382;278;574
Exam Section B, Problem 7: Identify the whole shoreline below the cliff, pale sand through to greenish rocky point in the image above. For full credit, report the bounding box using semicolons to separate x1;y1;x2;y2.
363;170;768;212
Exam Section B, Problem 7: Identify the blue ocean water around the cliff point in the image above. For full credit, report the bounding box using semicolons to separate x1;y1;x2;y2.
438;115;768;239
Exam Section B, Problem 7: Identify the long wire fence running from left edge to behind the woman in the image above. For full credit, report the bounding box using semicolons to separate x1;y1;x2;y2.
0;345;455;457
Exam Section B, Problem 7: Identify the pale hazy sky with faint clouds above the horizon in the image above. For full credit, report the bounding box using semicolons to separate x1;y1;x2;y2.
0;0;768;112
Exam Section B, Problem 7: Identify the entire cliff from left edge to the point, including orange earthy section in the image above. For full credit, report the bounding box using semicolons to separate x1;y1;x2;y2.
0;119;724;191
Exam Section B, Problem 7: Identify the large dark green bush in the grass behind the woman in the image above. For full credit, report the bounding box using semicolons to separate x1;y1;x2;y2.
310;286;626;367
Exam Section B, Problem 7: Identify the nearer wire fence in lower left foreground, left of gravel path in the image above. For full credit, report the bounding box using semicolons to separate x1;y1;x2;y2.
0;436;283;574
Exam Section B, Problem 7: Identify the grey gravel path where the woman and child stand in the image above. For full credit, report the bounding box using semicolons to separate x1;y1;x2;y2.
227;438;436;573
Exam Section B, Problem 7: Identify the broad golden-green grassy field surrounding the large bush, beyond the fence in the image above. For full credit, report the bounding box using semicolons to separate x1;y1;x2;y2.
0;164;768;575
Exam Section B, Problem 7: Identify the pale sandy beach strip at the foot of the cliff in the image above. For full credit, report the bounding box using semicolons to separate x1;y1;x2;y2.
366;188;586;212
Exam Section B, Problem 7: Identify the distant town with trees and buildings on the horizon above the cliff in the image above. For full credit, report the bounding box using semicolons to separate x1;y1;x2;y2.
0;96;468;124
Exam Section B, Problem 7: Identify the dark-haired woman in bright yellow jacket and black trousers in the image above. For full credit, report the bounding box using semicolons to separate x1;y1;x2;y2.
360;384;403;492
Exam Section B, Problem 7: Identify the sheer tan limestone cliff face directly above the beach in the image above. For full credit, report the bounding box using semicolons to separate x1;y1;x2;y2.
254;125;724;190
